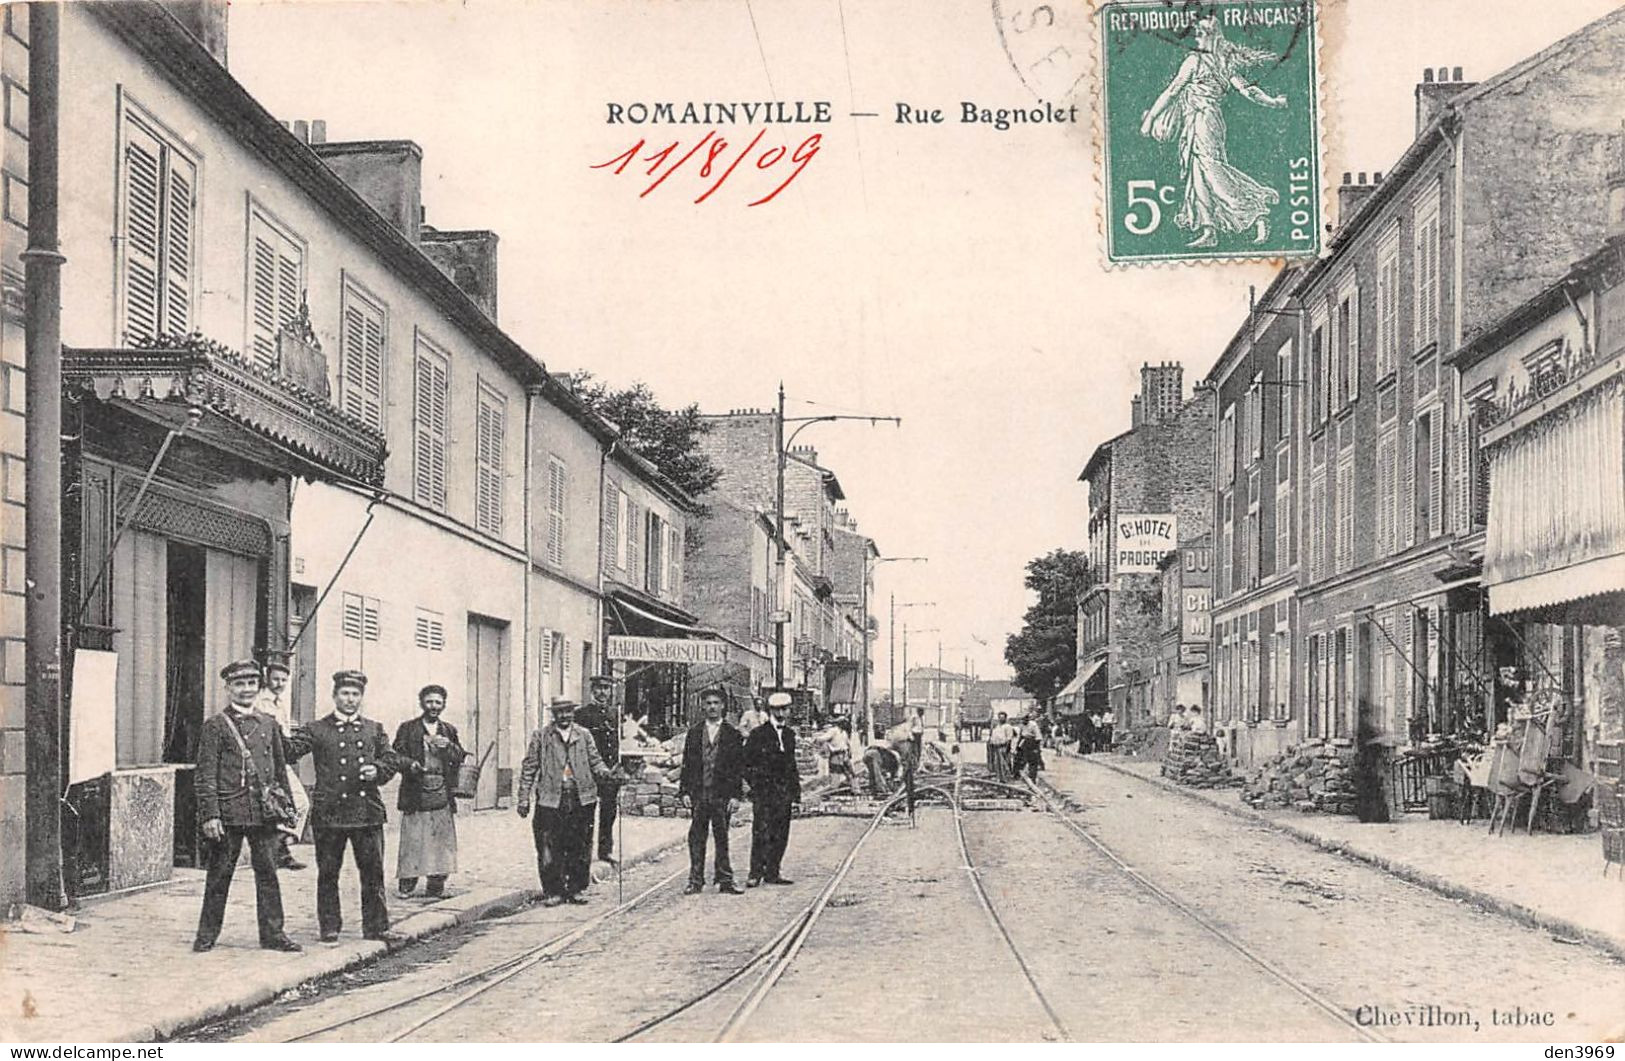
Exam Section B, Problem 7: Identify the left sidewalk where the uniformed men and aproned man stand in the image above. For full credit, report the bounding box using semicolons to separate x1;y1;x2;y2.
0;809;689;1043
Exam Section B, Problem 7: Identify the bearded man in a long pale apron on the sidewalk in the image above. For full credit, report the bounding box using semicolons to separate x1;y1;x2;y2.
395;686;468;899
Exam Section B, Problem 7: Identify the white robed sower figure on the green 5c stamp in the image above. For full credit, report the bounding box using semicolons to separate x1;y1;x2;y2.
1139;15;1287;247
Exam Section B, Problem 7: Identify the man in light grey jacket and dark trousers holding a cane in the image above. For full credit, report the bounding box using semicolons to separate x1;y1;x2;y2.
515;700;609;907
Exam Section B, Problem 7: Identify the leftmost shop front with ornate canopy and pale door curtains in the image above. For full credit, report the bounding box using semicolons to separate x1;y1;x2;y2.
63;343;385;895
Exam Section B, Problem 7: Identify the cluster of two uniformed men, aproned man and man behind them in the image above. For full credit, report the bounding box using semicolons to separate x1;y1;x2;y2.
192;660;468;952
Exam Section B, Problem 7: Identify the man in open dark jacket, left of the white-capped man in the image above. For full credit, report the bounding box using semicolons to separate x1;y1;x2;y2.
678;686;744;895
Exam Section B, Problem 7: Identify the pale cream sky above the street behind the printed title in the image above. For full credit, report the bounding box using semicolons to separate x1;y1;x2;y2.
229;0;1615;679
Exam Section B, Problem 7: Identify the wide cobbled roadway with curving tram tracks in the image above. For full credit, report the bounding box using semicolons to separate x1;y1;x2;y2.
184;751;1625;1042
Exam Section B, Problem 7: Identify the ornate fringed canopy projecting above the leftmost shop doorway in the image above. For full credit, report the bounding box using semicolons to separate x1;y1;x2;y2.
62;346;387;486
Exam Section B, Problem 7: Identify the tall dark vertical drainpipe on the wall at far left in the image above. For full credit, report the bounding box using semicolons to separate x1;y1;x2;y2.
23;3;67;910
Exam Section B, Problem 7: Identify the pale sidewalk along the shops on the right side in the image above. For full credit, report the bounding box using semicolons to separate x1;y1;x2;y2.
1068;754;1625;959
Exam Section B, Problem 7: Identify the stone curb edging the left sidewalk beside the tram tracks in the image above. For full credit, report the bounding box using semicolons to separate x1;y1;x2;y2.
123;835;687;1043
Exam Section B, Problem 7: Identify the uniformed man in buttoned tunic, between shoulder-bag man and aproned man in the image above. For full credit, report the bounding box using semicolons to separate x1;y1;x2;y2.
288;671;400;942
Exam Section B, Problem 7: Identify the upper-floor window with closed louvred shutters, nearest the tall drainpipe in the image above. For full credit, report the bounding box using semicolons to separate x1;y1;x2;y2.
118;107;197;343
